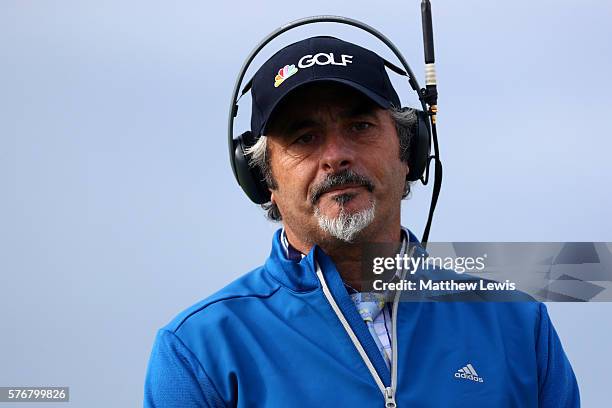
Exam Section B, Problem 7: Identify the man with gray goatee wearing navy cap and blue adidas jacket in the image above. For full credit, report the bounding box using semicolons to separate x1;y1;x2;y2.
144;37;579;408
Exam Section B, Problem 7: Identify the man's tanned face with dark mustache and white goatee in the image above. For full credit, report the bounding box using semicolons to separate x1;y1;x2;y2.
267;83;408;243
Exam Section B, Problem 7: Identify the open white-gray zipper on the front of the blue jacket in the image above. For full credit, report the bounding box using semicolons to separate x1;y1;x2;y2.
315;239;414;408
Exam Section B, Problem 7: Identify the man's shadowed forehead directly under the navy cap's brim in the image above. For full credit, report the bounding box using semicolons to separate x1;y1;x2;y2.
266;82;381;136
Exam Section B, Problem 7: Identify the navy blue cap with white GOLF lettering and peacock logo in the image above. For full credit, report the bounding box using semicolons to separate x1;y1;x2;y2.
251;37;400;137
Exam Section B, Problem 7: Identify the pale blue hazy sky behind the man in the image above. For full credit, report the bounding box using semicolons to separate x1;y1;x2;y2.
0;0;612;408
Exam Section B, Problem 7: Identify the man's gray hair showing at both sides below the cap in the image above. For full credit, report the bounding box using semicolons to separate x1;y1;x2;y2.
246;107;417;221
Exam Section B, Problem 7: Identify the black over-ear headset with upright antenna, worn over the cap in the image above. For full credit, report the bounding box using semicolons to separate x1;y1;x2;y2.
227;12;442;245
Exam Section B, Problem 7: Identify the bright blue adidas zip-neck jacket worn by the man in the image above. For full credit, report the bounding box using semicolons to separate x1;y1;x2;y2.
144;231;580;408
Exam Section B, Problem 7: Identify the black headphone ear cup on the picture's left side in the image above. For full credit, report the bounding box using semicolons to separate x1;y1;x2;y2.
233;131;270;204
